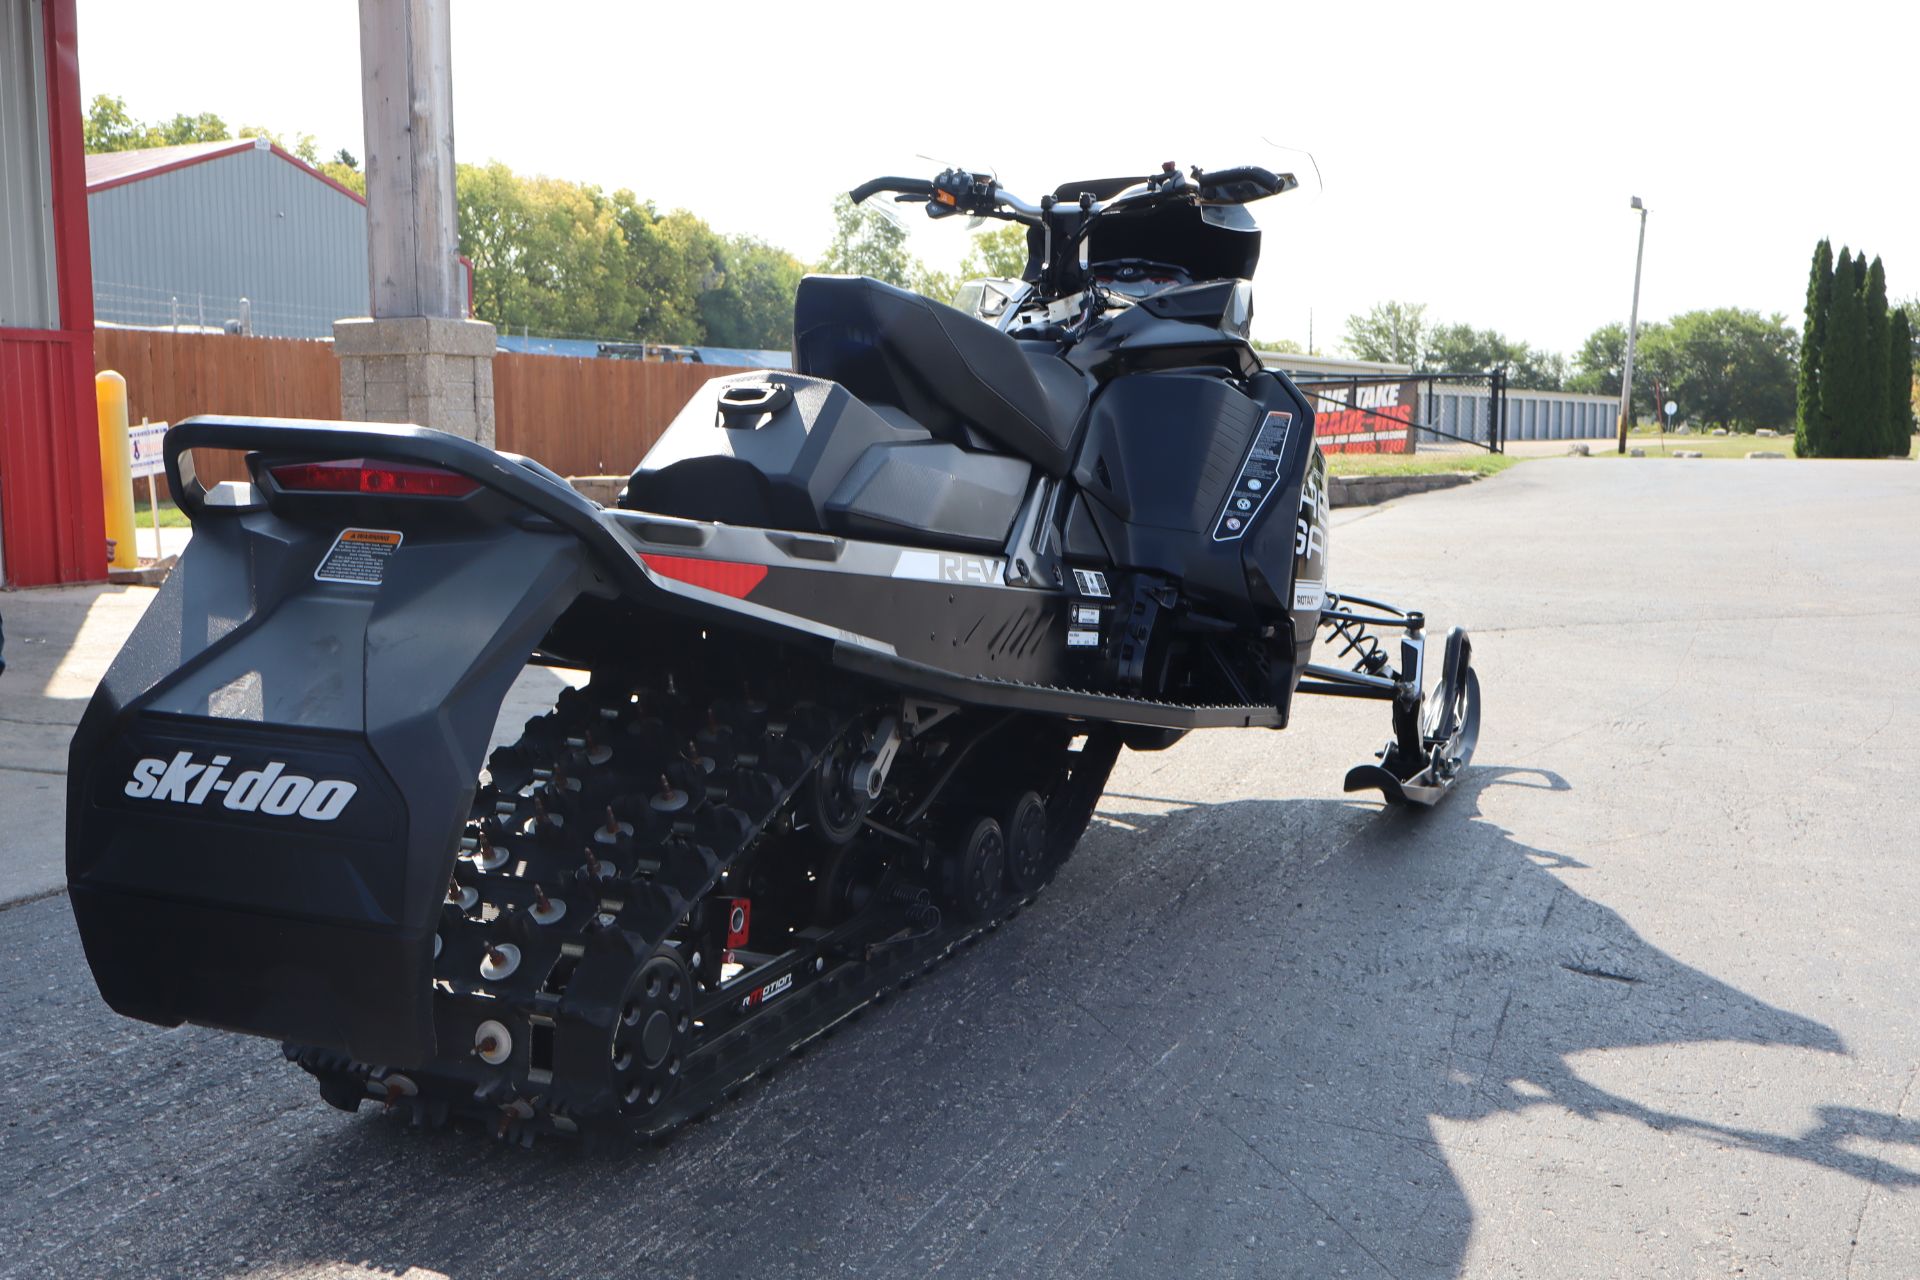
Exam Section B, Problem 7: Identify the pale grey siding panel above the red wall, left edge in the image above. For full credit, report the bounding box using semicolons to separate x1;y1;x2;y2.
0;0;60;328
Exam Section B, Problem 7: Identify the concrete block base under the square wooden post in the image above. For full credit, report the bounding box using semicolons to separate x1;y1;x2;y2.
334;315;493;449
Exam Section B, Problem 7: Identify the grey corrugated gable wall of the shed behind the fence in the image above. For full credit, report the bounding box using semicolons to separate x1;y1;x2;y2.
86;150;369;338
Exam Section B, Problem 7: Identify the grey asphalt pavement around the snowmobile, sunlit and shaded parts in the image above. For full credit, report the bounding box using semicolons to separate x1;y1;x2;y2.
0;459;1920;1280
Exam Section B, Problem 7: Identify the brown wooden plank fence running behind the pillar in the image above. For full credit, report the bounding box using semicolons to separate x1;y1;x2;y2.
94;328;741;495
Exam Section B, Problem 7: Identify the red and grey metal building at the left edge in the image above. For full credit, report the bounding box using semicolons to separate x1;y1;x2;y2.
0;0;108;587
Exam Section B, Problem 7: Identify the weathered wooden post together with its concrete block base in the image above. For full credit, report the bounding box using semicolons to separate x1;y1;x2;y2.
334;0;495;445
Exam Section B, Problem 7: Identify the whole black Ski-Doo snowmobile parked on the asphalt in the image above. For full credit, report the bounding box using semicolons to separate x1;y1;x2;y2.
67;165;1478;1140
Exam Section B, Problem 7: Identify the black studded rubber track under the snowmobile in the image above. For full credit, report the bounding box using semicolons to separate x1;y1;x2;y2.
286;676;1117;1144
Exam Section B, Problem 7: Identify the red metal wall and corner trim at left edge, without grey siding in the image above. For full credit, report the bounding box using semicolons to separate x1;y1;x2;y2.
0;0;108;587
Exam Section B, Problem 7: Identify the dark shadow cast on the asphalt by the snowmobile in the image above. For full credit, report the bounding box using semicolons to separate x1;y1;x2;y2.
0;768;1920;1278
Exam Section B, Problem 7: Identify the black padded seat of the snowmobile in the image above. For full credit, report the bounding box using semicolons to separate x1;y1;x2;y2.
793;276;1087;476
